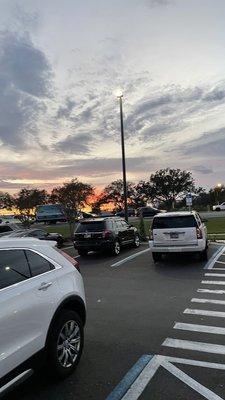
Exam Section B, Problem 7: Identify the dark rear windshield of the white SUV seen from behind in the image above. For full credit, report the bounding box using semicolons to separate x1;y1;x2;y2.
152;215;197;229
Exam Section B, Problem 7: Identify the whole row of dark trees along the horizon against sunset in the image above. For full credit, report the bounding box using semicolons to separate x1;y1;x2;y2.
0;168;225;215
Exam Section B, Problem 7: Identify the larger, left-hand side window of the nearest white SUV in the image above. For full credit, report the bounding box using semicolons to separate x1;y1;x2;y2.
0;250;31;289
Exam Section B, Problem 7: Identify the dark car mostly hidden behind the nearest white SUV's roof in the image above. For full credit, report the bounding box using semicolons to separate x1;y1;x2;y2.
3;229;65;248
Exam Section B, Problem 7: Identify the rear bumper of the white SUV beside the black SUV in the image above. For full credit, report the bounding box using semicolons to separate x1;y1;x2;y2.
148;239;206;253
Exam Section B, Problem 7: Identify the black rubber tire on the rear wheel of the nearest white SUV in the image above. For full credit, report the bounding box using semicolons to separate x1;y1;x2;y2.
46;310;84;379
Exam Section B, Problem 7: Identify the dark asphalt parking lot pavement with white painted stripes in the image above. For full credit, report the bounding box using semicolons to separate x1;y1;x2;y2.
4;245;225;400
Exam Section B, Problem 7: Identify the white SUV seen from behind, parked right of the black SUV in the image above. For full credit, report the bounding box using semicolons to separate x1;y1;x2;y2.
149;211;208;261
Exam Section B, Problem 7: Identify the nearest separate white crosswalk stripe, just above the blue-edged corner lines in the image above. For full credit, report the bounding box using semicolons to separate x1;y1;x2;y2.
162;338;225;354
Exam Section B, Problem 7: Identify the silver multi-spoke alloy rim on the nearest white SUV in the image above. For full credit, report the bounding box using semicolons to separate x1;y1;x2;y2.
57;320;81;368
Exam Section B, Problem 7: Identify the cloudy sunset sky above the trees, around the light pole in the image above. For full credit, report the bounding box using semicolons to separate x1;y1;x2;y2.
0;0;225;193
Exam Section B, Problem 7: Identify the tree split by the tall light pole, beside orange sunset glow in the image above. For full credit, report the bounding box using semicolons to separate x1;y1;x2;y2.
102;179;135;211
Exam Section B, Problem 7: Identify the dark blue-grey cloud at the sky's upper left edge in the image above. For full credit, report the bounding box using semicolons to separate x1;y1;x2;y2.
0;32;52;150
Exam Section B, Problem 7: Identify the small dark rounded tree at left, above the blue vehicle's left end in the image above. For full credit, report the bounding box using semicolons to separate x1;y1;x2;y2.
15;188;48;215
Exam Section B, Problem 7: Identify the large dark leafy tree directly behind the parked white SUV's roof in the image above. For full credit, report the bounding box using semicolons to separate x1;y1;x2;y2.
149;168;196;208
